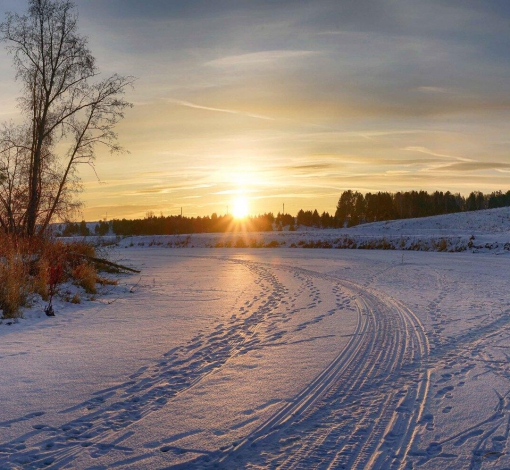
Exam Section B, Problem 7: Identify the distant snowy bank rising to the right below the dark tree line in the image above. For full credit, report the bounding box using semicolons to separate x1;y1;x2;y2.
103;207;510;253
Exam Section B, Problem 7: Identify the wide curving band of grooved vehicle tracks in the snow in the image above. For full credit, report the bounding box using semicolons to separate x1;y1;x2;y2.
214;262;429;469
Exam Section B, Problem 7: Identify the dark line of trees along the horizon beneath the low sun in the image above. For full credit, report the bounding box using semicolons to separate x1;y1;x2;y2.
57;190;510;236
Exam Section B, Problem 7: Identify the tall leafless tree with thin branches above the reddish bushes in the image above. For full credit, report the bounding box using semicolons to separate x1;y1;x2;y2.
0;0;134;236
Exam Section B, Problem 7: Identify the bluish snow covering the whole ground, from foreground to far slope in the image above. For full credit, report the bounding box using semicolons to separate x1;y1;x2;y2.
0;209;510;469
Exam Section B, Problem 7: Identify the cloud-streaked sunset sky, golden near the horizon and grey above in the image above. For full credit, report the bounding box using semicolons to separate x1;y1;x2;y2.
0;0;510;220
